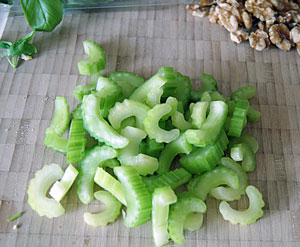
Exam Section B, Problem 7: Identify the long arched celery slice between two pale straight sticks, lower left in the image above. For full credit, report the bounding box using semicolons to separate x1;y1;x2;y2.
77;146;117;204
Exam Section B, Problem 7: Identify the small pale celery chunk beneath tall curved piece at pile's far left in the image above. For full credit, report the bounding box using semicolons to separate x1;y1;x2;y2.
44;128;68;154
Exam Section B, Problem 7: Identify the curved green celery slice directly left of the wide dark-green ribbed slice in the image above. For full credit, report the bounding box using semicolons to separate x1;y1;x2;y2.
157;134;193;174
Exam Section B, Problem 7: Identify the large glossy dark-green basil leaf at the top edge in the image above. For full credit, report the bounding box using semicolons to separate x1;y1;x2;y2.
21;0;63;32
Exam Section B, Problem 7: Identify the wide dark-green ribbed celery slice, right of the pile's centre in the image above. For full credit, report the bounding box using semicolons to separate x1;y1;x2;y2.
179;130;229;174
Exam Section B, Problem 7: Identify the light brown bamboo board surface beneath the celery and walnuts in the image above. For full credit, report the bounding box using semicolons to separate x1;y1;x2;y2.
0;6;300;247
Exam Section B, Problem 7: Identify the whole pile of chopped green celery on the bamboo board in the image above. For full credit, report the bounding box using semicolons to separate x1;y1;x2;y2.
27;41;264;246
